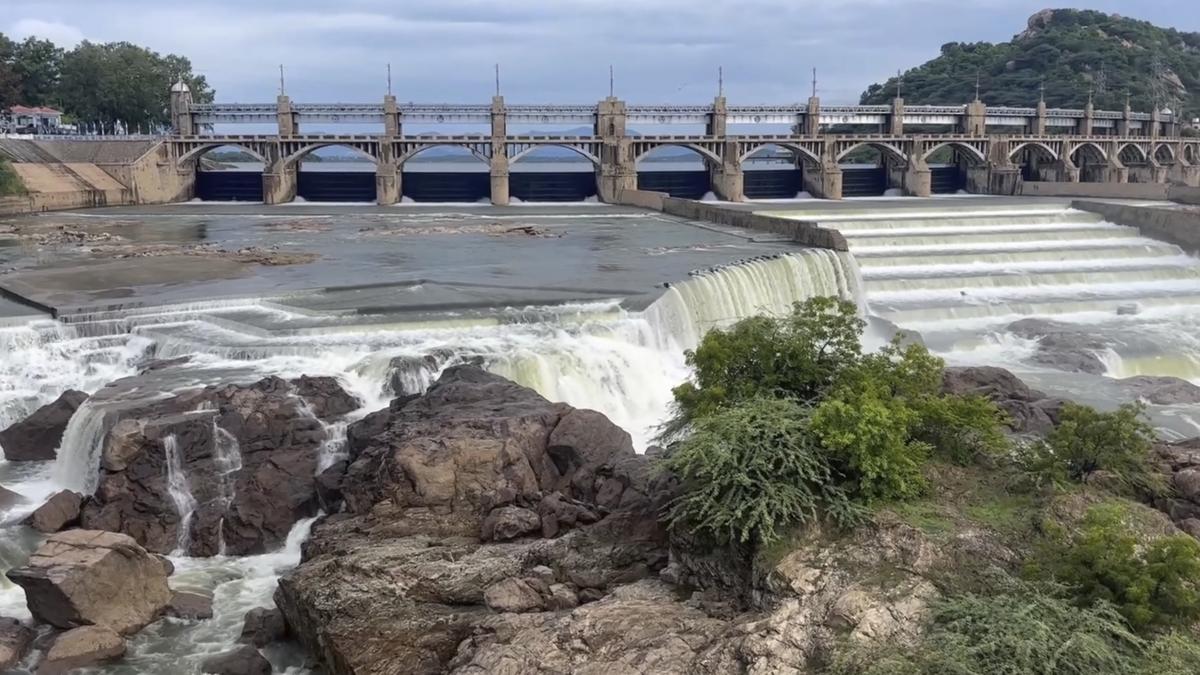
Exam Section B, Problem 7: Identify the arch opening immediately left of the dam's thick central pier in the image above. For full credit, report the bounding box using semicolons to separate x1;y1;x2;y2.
509;144;600;202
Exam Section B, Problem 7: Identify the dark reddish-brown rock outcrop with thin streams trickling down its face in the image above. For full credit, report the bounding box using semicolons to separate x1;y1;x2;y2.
80;377;358;556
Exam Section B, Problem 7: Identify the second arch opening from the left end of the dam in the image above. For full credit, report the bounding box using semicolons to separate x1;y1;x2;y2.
292;143;377;203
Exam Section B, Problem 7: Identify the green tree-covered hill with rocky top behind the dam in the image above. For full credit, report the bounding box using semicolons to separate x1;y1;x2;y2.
862;10;1200;117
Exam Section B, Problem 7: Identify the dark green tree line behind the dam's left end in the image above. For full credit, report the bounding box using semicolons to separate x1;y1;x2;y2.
0;34;215;129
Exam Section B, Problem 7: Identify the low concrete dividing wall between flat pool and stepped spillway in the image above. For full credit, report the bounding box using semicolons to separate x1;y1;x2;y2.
619;190;848;251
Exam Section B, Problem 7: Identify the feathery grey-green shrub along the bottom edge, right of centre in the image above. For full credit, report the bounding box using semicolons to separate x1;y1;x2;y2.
827;585;1146;675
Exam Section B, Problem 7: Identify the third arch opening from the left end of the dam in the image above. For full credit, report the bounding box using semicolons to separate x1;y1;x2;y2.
400;145;492;204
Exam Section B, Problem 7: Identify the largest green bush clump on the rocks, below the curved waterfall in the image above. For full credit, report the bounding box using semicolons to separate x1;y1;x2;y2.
664;298;1007;548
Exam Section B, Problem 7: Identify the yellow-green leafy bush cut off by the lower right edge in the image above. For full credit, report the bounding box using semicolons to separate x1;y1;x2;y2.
1028;502;1200;631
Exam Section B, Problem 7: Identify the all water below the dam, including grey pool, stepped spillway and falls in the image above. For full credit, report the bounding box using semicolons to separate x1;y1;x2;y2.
0;196;1200;675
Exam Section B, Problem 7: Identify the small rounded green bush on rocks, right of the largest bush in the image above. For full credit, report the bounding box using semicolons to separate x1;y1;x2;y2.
1027;402;1165;492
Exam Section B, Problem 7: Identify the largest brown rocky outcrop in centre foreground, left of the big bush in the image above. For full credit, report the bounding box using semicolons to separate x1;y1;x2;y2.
276;366;670;674
